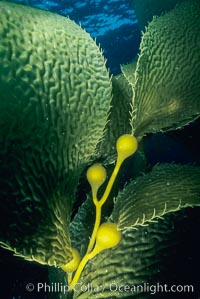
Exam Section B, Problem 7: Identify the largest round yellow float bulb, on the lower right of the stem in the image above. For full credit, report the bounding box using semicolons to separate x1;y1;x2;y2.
96;222;121;250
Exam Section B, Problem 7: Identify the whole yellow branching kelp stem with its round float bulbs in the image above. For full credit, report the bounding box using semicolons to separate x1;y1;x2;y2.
62;134;138;289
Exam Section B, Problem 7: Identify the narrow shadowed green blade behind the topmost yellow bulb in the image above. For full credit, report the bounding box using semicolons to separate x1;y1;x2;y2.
97;59;146;175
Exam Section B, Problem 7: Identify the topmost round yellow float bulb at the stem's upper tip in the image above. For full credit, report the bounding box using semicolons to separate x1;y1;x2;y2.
116;134;138;160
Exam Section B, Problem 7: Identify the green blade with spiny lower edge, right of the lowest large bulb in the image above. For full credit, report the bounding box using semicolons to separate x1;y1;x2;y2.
112;164;200;229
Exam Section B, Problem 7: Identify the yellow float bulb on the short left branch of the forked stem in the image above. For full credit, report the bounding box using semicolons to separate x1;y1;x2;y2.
87;163;106;189
